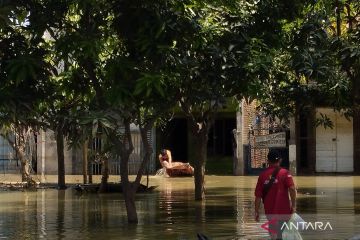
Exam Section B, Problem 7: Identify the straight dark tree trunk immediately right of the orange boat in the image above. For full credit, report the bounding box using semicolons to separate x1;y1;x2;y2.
194;130;208;201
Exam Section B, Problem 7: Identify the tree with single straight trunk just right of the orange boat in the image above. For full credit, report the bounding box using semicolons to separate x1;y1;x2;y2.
167;1;308;200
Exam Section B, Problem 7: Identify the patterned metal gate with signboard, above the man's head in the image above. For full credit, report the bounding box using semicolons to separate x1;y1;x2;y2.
244;128;290;175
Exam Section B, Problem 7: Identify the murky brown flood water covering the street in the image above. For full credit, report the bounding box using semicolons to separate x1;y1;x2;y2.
0;176;360;239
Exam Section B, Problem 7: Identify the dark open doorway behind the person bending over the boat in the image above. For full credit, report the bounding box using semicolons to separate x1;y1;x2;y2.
160;119;188;162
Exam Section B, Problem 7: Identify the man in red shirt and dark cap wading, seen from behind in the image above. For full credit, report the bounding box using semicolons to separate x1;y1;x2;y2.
255;150;296;239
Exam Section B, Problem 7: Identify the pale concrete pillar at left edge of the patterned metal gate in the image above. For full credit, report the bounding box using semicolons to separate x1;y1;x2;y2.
234;101;244;176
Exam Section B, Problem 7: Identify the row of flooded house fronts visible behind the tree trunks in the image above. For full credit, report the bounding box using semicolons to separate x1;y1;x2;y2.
0;101;355;175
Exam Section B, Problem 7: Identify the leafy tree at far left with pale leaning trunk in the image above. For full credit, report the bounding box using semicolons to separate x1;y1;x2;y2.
0;1;50;184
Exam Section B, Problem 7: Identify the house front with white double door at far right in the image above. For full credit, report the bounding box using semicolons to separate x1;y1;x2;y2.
297;108;354;174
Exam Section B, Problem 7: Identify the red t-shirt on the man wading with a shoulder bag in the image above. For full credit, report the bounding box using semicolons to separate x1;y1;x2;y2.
255;166;294;215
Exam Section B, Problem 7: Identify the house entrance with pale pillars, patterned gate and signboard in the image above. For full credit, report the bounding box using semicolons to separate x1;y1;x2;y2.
234;100;296;175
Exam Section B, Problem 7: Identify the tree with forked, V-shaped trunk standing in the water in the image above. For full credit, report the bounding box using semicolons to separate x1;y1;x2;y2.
40;1;181;223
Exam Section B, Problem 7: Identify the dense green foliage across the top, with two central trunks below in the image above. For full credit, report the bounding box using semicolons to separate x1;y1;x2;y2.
0;0;360;219
